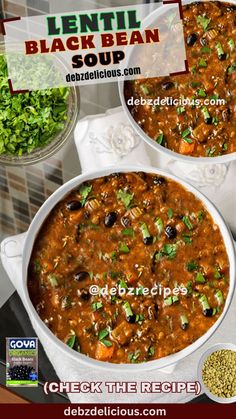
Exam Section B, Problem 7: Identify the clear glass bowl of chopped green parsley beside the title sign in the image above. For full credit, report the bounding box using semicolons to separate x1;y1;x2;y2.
0;44;78;165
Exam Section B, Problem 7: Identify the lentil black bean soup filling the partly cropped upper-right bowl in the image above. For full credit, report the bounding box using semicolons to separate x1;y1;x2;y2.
124;1;236;157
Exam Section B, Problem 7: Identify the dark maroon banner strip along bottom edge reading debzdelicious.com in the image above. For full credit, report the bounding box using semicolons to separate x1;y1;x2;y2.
0;403;236;419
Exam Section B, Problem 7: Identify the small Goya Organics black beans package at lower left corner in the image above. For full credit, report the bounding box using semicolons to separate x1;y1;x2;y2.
6;338;38;387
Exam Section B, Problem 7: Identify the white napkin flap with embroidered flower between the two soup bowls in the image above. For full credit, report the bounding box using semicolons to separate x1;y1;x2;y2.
74;107;150;172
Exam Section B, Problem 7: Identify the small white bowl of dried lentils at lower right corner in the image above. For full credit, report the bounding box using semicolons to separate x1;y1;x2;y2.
198;343;236;403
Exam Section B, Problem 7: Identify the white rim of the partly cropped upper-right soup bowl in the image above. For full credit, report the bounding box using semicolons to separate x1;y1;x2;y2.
118;0;236;164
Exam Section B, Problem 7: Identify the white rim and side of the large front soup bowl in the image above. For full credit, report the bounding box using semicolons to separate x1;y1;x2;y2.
15;166;235;372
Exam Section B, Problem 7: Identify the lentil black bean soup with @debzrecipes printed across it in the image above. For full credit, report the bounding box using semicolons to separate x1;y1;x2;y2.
28;172;229;363
